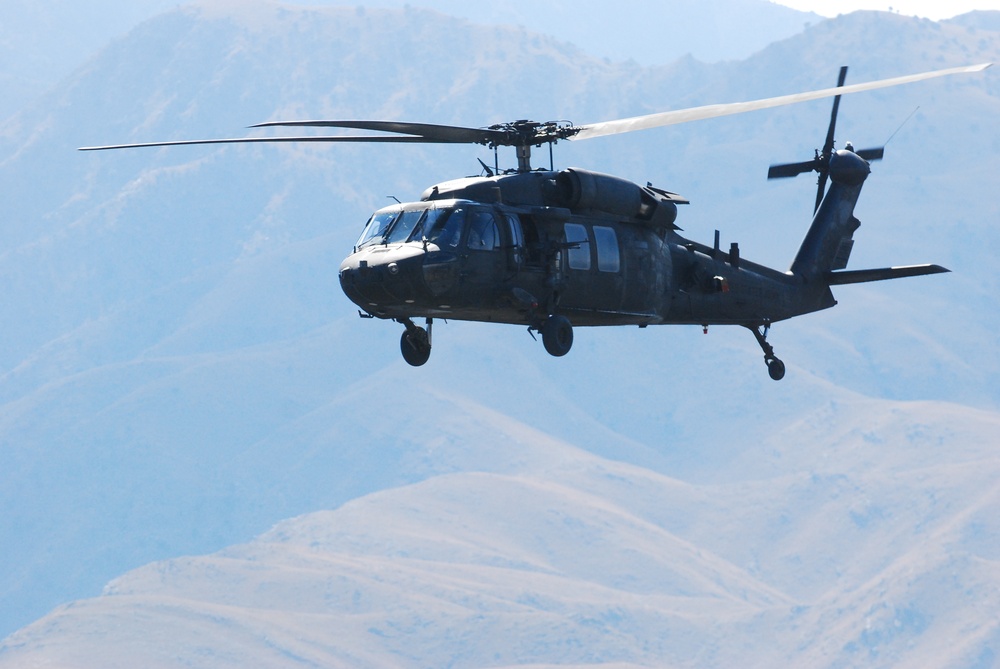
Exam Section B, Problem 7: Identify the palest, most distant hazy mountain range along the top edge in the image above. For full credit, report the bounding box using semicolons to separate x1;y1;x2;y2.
0;0;820;119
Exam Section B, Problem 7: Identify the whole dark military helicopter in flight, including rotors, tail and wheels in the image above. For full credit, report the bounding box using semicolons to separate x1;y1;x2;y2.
80;63;990;380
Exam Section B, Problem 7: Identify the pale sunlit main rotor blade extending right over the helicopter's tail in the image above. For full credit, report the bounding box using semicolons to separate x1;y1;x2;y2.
569;63;992;140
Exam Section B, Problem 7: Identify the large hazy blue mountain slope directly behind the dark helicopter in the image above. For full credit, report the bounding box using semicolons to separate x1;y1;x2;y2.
0;3;1000;653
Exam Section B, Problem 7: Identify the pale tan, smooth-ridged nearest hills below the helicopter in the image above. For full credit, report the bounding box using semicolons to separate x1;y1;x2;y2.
0;398;1000;668
